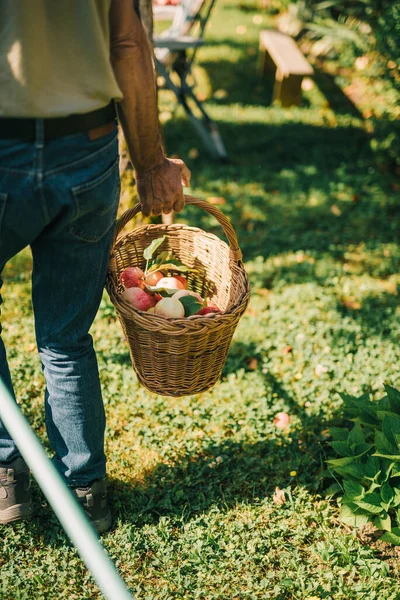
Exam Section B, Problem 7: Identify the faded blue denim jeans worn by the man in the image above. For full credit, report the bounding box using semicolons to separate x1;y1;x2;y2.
0;119;119;486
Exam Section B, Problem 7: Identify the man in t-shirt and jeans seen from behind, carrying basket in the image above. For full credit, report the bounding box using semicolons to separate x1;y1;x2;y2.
0;0;190;532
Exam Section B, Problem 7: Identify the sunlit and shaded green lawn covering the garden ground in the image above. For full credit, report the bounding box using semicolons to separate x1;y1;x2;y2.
0;0;400;600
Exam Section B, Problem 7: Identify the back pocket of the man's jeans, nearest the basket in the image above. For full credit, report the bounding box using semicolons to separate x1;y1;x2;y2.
69;158;120;242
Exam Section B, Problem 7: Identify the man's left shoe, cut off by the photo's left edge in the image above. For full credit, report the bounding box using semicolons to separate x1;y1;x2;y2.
0;457;33;525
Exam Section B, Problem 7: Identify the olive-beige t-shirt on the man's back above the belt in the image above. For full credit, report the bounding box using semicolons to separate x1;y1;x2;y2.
0;0;122;118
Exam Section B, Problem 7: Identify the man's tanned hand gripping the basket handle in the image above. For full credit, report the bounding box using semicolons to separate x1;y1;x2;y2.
136;158;191;217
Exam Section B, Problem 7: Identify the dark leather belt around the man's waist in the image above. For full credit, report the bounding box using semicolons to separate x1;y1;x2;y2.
0;101;116;141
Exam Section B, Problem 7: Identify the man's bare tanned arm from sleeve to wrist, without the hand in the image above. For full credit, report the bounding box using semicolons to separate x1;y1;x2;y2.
110;0;164;174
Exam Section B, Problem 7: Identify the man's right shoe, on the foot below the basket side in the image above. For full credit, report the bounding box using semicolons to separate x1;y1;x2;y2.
72;479;112;533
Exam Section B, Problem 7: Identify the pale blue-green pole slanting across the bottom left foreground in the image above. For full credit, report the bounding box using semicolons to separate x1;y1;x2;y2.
0;380;135;600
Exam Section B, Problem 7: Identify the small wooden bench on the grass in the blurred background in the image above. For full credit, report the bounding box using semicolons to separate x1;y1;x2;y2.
260;30;314;106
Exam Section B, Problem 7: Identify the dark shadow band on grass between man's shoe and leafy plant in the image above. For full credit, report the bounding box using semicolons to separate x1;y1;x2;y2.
106;419;327;527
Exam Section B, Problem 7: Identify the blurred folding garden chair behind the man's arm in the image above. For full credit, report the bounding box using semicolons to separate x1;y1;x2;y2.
154;0;227;161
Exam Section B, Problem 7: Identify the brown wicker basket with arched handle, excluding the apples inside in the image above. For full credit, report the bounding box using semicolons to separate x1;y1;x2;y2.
106;196;250;396
